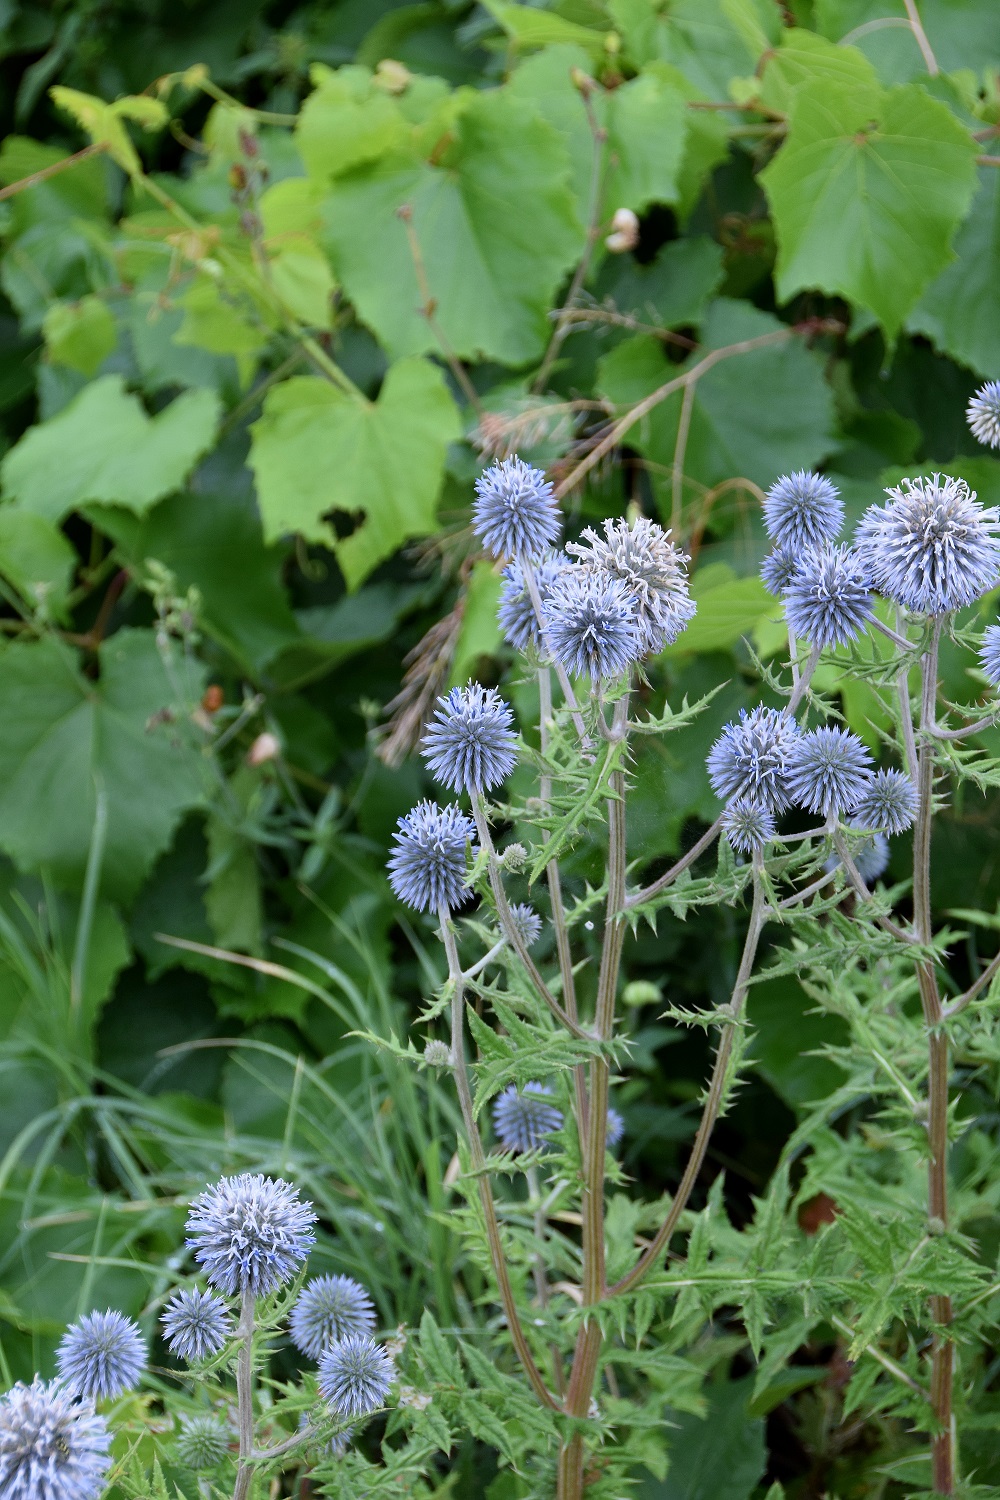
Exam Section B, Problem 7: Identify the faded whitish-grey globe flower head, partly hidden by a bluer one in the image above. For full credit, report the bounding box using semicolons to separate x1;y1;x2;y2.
567;516;697;653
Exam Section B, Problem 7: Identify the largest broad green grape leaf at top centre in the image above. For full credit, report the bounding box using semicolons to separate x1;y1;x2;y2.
324;90;583;365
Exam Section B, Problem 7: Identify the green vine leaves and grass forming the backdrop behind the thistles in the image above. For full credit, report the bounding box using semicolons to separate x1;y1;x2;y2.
0;0;1000;1500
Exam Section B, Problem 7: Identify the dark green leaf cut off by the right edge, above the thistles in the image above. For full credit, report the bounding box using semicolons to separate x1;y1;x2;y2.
907;167;1000;380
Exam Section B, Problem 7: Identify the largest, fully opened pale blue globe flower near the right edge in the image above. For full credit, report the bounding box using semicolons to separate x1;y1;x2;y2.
858;474;1000;615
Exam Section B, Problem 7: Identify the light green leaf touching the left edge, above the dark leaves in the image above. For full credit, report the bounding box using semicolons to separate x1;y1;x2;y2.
0;375;220;521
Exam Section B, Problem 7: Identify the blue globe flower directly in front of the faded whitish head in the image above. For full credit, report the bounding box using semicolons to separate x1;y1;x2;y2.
544;567;643;683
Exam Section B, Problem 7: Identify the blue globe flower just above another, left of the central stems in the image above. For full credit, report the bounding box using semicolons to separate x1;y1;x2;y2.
421;683;517;792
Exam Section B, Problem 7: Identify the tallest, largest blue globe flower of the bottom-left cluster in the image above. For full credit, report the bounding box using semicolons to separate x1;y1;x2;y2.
187;1172;316;1298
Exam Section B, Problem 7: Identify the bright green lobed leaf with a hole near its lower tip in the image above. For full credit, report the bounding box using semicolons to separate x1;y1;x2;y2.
249;359;460;590
